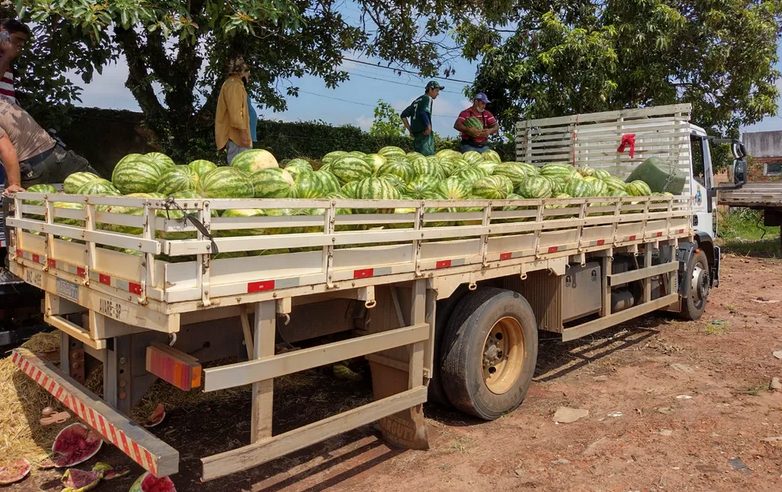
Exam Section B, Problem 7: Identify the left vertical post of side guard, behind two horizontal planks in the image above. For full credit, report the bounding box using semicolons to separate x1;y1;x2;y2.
253;301;277;442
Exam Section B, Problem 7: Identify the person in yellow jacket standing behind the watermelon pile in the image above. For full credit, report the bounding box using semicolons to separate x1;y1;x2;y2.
215;57;253;164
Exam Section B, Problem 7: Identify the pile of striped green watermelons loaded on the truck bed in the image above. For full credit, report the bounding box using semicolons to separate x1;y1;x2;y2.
24;146;652;239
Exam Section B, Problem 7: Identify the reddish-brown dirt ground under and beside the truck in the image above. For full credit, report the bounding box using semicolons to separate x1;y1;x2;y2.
13;256;782;492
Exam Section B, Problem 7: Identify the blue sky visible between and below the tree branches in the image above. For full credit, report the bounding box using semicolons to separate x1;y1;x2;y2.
71;37;782;136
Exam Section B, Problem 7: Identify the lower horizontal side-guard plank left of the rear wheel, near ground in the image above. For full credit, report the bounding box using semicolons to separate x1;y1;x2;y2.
201;386;427;481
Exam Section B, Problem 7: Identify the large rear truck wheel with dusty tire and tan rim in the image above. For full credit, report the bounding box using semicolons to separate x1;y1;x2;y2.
440;287;538;420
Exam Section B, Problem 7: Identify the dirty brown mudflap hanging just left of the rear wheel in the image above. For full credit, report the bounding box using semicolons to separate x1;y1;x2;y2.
369;358;429;450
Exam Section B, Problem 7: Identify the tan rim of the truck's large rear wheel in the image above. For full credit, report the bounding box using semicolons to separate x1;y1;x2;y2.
483;316;524;395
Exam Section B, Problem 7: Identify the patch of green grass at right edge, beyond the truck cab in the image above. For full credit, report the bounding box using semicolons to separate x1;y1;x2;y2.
717;208;782;258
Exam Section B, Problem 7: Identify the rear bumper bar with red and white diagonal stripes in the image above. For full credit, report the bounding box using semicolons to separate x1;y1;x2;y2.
11;349;179;477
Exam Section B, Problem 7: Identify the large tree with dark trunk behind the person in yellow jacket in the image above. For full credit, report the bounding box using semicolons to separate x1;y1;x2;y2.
17;0;478;160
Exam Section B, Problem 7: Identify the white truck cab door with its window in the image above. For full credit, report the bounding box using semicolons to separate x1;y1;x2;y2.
690;131;715;237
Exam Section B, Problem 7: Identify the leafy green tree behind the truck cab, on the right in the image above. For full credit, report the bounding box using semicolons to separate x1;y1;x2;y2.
458;0;782;135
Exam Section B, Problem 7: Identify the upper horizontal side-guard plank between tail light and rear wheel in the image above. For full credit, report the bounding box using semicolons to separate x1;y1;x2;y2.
204;323;429;391
